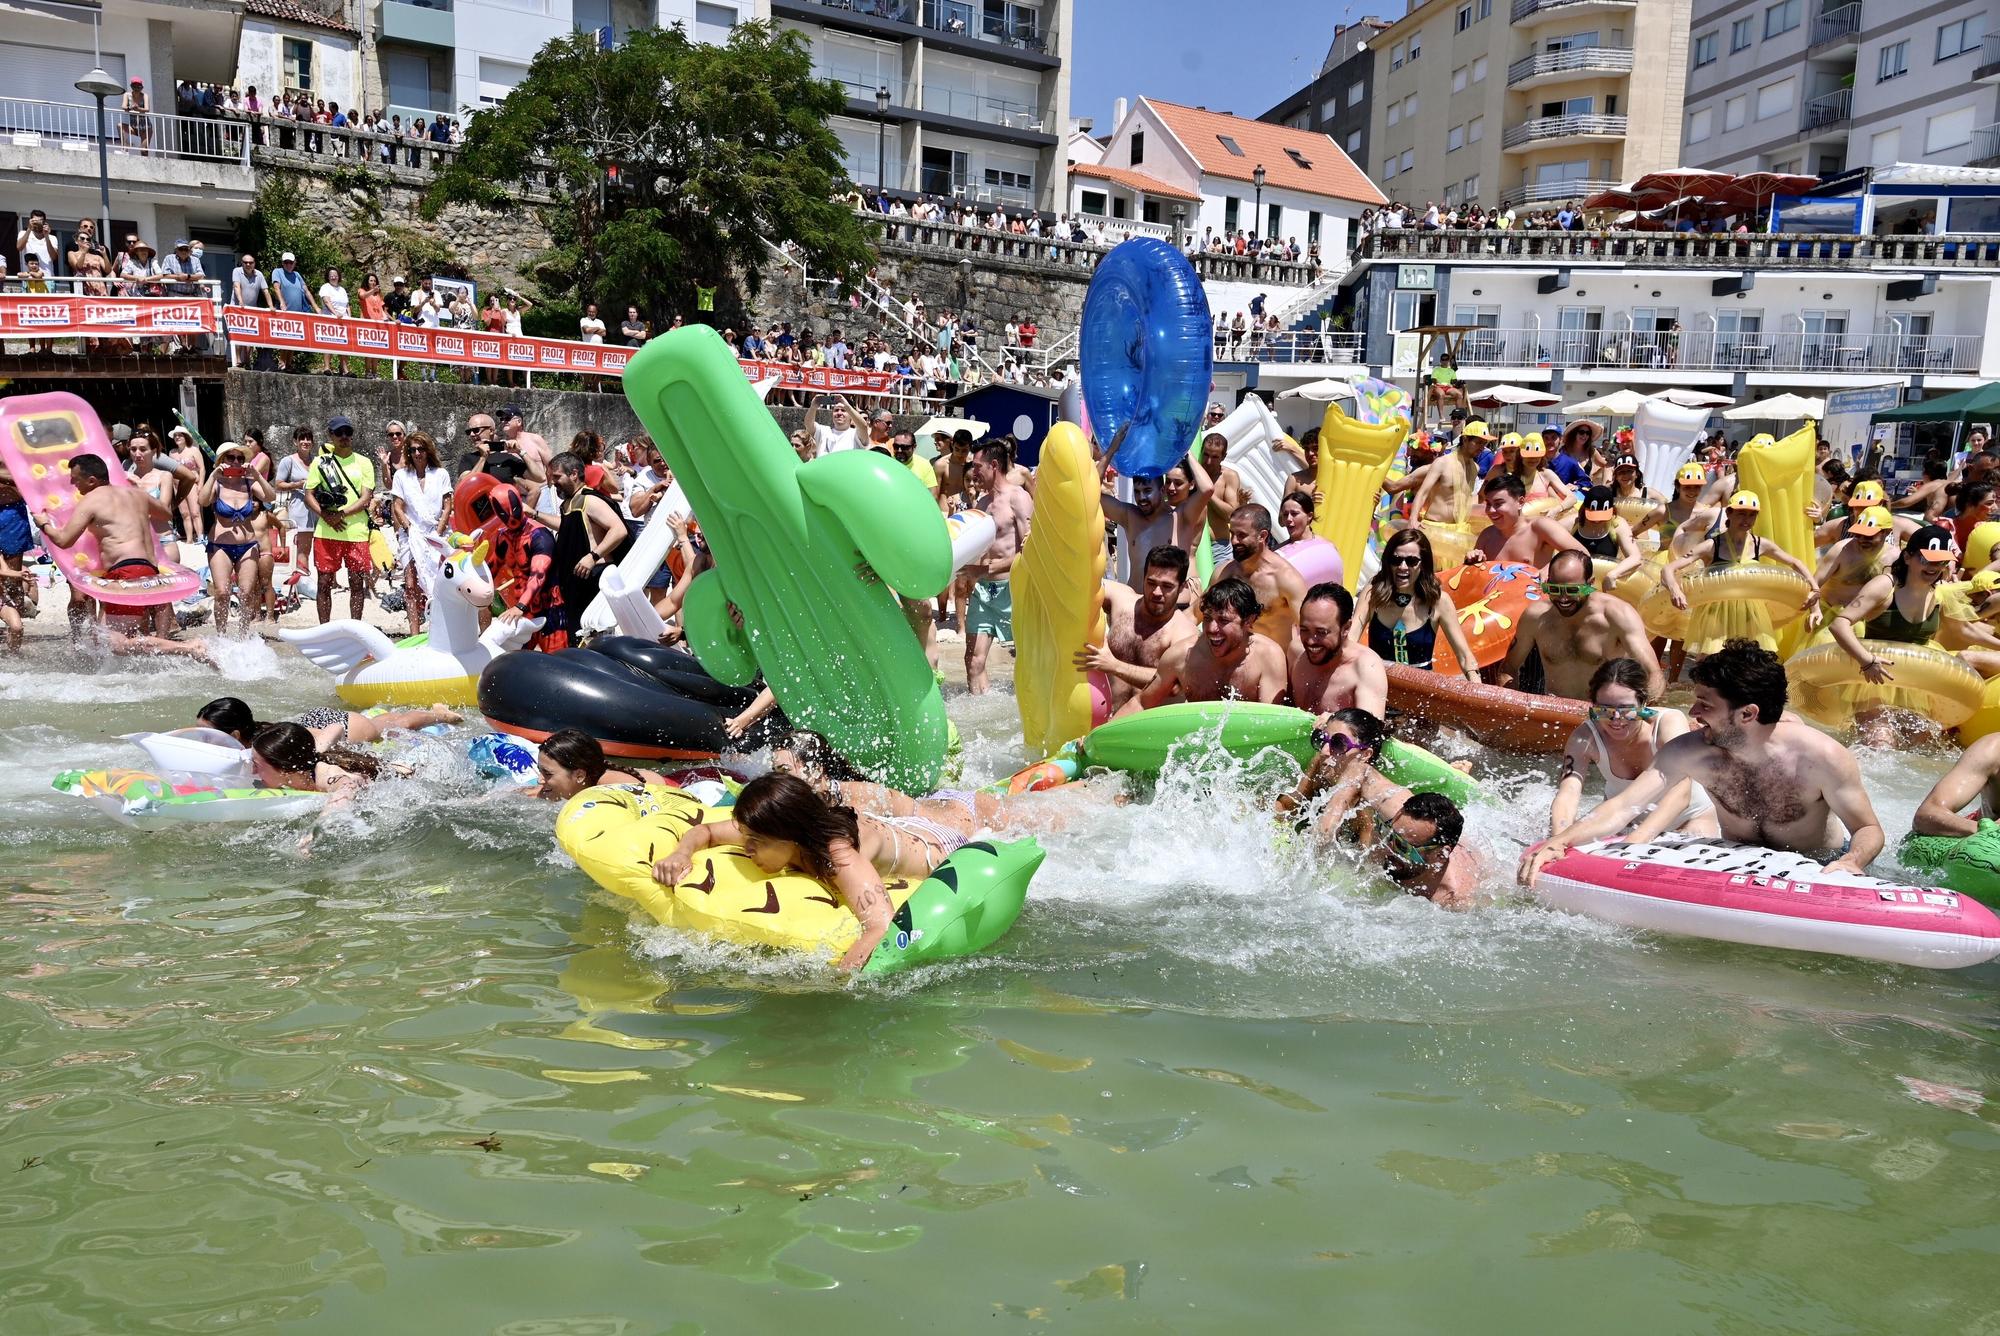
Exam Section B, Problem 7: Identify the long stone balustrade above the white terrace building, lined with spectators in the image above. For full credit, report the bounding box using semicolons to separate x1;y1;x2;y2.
1354;228;2000;270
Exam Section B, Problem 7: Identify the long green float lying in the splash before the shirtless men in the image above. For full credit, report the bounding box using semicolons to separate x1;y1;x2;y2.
1080;700;1480;808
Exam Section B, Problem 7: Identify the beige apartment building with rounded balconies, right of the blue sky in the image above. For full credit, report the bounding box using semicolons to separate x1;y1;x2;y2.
1368;0;1690;206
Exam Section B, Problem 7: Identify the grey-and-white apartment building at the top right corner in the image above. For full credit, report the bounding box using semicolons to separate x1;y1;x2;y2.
1682;0;2000;176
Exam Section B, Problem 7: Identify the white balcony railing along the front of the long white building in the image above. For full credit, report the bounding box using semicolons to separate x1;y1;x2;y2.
1458;328;1984;376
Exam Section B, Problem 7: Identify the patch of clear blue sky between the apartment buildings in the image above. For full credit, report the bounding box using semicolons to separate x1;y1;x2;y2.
1070;0;1404;134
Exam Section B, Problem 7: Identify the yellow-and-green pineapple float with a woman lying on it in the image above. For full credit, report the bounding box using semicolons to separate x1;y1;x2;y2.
556;786;1044;974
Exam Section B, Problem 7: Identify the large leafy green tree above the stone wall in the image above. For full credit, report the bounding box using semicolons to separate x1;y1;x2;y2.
424;24;874;324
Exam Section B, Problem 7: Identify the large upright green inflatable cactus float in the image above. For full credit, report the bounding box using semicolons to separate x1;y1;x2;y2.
624;326;952;794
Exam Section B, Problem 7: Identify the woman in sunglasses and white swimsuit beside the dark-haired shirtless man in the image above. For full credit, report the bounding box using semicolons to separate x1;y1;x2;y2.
1548;658;1720;838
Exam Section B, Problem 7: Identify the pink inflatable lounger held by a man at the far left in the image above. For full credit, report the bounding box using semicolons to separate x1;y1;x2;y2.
0;392;206;608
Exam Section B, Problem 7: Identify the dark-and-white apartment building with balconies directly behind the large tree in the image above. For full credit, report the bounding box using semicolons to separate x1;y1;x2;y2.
760;0;1072;212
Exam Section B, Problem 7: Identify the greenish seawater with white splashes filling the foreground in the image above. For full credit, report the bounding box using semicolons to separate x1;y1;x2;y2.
0;646;2000;1336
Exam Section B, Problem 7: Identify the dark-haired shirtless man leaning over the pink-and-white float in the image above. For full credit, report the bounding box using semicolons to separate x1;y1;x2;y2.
1520;640;1882;886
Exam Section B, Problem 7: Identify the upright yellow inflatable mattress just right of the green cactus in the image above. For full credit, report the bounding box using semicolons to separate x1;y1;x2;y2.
1010;422;1108;756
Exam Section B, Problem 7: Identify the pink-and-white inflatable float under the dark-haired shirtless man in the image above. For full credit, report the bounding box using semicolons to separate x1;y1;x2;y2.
1534;836;2000;970
